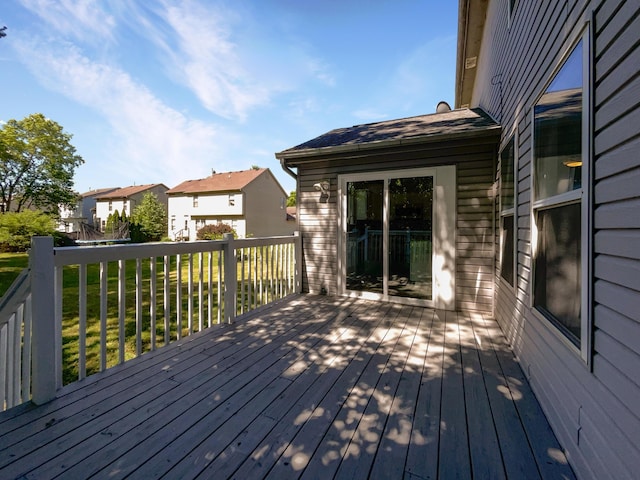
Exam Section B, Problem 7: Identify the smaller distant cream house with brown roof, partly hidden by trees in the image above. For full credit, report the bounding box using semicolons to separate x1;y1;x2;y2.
95;183;169;231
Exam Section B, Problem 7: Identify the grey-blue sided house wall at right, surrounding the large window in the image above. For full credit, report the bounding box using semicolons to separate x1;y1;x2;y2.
472;0;640;479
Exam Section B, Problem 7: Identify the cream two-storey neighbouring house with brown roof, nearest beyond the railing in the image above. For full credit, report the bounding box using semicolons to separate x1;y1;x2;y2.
167;168;296;240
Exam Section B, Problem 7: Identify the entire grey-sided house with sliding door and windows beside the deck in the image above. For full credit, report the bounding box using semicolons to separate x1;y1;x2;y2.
276;0;640;479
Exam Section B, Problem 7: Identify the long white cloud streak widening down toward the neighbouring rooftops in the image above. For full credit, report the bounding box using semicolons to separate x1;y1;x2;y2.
14;37;228;186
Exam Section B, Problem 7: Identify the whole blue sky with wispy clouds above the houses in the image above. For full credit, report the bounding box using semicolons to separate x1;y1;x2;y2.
0;0;458;192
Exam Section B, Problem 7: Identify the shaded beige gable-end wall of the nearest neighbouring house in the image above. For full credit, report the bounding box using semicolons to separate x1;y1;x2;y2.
244;170;295;237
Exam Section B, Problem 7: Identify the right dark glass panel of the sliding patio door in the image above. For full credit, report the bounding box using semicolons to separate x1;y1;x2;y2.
388;176;433;300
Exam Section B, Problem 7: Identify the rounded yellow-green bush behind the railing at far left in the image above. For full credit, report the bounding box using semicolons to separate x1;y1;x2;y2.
0;210;57;252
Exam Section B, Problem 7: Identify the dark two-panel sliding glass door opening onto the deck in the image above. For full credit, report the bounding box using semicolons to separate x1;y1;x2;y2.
343;174;434;300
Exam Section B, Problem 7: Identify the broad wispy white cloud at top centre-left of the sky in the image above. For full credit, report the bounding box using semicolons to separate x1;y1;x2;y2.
127;0;336;122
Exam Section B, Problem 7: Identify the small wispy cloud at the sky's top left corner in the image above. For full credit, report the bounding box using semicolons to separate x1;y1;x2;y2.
21;0;115;41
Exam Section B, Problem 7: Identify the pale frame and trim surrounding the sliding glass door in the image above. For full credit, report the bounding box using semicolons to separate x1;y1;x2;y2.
337;165;456;310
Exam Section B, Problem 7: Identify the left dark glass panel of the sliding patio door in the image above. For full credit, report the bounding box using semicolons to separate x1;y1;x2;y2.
346;180;384;293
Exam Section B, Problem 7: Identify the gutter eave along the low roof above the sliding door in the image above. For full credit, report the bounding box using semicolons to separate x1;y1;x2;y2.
275;125;501;165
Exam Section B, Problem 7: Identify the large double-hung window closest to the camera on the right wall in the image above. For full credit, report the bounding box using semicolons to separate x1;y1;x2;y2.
532;39;590;355
